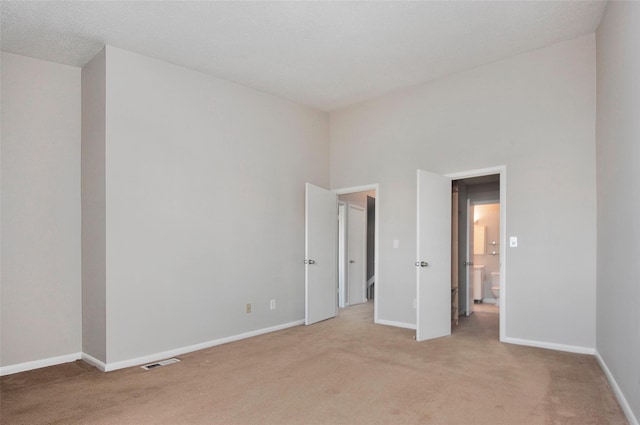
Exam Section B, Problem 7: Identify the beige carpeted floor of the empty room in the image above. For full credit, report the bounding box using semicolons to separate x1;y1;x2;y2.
0;303;627;425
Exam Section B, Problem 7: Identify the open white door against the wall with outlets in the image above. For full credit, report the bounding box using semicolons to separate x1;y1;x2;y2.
304;183;338;325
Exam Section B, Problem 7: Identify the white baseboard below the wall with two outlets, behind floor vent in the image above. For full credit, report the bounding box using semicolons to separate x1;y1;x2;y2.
104;320;304;372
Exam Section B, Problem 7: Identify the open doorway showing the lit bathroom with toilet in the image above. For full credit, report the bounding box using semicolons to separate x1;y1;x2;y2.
451;174;503;334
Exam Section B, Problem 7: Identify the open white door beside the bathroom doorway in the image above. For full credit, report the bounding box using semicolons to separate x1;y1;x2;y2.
416;170;451;341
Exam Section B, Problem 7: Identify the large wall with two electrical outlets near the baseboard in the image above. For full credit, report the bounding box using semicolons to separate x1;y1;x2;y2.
99;46;329;363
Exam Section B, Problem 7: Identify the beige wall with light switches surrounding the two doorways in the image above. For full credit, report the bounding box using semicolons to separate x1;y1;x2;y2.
330;35;596;349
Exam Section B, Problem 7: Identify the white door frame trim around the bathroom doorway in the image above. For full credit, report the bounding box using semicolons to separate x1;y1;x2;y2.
448;165;507;341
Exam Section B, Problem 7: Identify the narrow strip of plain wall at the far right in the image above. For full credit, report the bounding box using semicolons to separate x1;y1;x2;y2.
596;2;640;423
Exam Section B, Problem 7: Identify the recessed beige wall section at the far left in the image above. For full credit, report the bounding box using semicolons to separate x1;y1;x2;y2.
0;53;81;367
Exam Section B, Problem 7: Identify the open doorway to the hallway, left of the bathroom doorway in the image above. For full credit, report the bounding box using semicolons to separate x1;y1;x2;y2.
334;185;378;322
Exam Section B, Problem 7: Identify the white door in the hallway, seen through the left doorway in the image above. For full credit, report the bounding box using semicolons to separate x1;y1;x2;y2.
347;204;367;305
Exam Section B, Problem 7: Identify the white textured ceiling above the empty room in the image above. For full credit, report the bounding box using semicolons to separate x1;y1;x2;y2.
0;1;606;111
